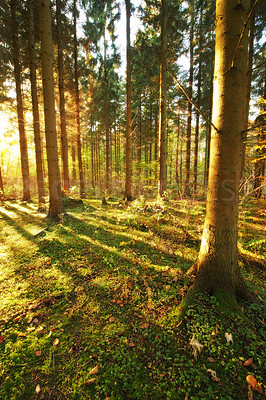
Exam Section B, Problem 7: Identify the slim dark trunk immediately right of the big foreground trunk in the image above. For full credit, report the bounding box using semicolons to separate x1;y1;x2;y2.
241;0;255;177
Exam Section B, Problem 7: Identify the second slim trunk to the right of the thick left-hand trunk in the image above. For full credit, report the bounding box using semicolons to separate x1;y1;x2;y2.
73;0;85;197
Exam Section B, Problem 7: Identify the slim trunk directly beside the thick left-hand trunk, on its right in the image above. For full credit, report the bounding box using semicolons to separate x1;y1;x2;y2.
56;0;69;194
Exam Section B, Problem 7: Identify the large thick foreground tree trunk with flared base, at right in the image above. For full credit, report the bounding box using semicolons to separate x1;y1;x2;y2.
189;0;250;298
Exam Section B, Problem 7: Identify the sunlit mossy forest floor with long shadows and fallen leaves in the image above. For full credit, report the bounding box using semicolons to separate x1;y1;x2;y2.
0;199;266;400
